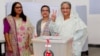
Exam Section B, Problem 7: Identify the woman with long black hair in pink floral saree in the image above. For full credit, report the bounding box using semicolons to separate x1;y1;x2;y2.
4;2;33;56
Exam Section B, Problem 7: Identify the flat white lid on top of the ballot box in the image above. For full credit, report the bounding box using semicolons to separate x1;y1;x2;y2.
32;36;72;43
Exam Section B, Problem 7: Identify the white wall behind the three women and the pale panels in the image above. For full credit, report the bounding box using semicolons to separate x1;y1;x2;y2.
0;0;100;44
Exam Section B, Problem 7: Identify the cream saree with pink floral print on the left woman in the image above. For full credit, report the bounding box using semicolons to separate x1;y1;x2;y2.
4;16;33;56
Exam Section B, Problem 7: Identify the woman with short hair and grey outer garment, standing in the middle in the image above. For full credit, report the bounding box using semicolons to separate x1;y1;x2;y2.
36;5;50;36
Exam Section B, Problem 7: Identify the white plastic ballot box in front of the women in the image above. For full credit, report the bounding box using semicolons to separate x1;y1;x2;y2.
32;36;73;56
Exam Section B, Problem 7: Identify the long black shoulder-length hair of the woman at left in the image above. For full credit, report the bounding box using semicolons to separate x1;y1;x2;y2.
10;2;26;21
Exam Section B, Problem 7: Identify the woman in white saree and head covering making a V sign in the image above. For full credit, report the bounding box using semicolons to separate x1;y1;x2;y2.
49;1;87;56
